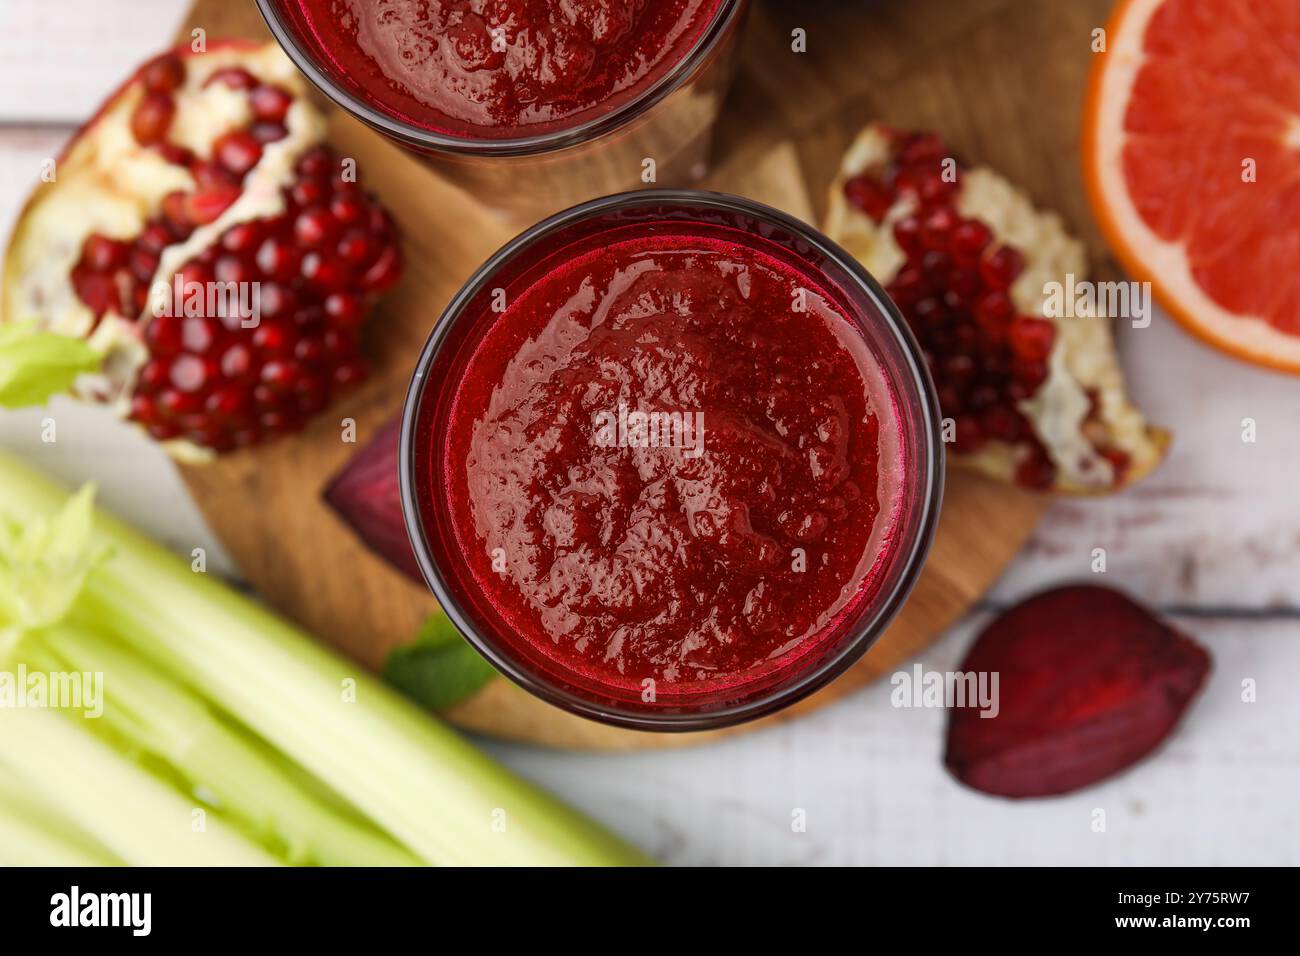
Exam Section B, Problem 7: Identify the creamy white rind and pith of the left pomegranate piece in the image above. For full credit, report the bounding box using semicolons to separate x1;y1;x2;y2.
0;40;325;460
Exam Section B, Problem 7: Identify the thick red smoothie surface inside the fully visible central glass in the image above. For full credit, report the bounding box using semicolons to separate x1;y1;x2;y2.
433;230;906;693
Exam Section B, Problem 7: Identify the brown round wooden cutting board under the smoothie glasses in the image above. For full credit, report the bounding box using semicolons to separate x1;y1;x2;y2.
170;0;1108;749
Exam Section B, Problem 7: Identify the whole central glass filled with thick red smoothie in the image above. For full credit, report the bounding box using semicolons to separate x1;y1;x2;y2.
400;190;943;730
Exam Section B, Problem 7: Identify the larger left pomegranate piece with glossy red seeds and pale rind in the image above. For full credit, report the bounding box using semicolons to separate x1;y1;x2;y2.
3;43;402;457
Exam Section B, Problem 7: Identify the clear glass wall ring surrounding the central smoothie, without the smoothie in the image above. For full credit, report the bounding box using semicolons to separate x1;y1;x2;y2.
399;190;944;731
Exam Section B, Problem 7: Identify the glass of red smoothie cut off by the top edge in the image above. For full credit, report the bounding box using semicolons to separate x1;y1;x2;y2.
257;0;749;222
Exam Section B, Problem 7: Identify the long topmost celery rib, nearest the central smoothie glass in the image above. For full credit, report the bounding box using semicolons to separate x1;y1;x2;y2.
0;457;650;865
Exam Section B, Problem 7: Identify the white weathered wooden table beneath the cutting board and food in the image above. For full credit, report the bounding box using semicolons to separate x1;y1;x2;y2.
0;0;1300;864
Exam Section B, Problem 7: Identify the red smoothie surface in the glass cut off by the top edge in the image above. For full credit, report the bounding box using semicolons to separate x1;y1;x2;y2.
282;0;725;139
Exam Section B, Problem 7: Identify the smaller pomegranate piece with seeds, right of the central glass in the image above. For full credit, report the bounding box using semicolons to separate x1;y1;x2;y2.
826;125;1169;493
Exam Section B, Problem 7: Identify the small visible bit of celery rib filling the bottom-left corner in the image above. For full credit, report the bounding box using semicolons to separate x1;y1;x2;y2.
0;766;122;866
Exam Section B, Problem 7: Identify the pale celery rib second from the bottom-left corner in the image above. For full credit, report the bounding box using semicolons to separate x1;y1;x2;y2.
0;708;278;866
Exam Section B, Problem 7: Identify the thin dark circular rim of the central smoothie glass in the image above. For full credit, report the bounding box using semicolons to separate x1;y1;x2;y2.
398;189;945;731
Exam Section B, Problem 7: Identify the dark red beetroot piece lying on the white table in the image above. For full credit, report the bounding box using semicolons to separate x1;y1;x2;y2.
944;585;1210;797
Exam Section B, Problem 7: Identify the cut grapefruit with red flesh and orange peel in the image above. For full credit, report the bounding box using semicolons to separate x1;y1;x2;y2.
1083;0;1300;373
